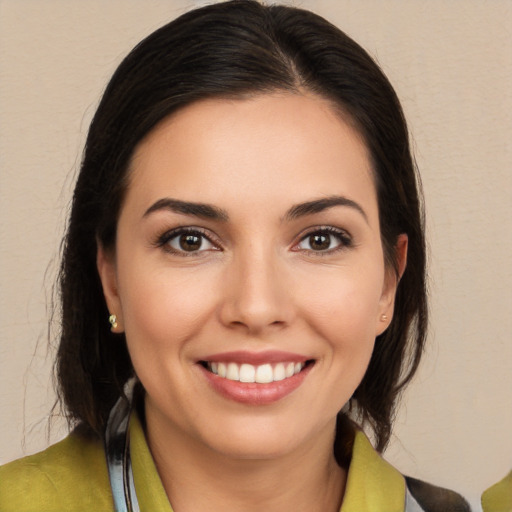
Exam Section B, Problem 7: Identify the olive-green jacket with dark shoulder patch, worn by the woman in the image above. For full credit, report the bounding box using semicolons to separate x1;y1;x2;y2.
0;414;470;512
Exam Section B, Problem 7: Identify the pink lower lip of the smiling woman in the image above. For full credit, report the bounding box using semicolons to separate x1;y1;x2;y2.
199;364;313;405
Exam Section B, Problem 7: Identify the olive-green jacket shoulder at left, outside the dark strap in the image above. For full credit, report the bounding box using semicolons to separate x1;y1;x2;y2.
0;433;113;512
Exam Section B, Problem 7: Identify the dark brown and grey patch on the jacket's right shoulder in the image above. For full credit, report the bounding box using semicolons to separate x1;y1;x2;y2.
405;476;471;512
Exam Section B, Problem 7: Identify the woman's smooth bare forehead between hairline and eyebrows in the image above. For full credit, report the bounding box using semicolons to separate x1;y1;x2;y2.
127;93;376;223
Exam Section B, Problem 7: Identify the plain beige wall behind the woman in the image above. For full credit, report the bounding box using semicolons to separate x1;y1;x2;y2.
0;0;512;504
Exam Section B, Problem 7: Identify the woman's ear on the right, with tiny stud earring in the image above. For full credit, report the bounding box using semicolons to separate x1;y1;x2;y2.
375;233;409;336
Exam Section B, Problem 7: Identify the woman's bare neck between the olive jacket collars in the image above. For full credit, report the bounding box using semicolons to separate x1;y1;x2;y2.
146;402;346;512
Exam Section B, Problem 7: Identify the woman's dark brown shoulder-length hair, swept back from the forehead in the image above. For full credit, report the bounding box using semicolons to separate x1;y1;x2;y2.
56;0;427;456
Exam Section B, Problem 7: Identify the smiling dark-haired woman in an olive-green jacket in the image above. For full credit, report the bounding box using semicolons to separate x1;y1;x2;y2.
0;1;468;512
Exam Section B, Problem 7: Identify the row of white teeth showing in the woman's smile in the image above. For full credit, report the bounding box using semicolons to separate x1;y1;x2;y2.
201;359;314;384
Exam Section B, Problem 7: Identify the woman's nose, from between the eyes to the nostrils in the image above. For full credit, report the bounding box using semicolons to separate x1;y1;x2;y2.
220;248;294;335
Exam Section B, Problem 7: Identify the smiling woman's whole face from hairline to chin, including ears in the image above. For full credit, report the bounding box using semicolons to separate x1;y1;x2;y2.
98;93;406;458
